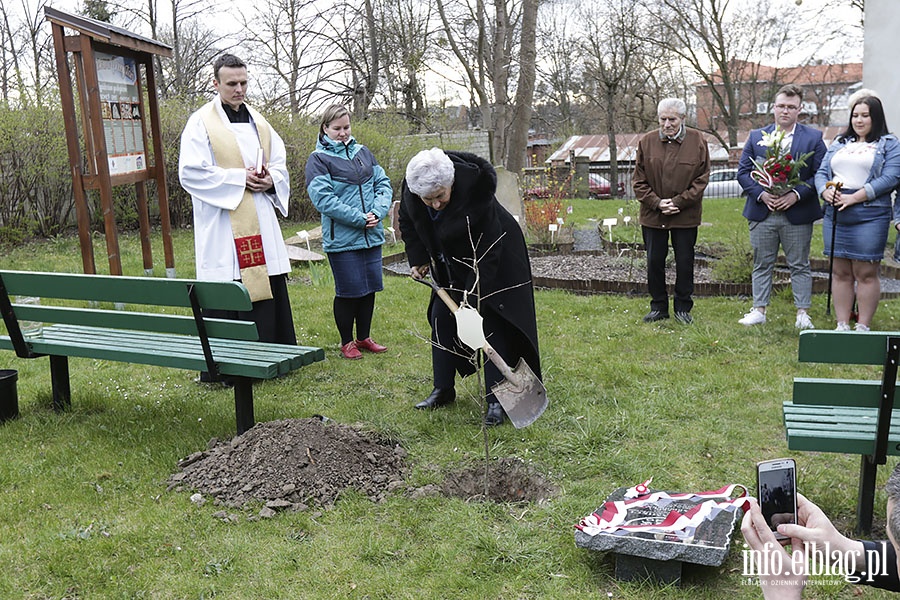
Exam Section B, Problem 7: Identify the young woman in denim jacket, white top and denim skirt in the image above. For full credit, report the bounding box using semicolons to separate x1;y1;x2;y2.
816;92;900;331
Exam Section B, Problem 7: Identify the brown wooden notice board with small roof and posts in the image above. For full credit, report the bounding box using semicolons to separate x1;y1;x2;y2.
44;6;175;277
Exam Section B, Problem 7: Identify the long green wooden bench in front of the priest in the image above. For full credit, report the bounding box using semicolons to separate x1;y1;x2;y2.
0;270;325;435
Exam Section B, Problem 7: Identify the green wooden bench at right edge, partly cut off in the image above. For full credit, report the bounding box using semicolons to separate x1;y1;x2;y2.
784;330;900;533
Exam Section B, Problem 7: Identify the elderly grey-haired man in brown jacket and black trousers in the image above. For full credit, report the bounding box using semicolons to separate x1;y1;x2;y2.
632;98;709;324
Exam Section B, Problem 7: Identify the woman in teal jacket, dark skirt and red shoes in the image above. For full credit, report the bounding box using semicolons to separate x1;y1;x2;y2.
306;104;393;359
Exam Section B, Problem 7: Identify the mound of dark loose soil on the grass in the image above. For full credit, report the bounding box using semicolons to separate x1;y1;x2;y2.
168;418;406;510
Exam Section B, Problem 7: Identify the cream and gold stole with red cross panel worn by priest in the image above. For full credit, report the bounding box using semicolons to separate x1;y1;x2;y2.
201;98;272;302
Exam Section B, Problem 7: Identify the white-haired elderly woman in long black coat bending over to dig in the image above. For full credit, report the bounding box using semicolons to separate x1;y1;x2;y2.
400;148;541;426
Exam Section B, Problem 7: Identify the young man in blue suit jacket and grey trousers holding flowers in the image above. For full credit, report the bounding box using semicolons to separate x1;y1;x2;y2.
738;85;825;329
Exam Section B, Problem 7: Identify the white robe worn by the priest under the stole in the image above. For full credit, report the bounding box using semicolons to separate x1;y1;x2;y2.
178;96;291;281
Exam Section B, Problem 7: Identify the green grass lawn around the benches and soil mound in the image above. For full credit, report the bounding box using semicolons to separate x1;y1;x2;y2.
0;199;900;600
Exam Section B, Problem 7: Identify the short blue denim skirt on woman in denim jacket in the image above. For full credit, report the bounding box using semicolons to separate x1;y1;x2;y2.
822;198;891;261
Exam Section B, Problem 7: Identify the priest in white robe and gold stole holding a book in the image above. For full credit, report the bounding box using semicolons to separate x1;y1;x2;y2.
178;54;297;358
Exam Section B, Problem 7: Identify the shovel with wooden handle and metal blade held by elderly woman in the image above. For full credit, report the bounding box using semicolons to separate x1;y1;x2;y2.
414;278;549;429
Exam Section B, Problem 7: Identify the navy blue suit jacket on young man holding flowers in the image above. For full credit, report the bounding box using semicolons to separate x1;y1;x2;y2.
738;123;826;225
